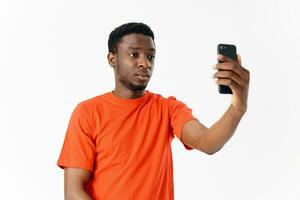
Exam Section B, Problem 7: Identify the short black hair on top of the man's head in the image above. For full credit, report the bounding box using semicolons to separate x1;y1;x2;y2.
108;22;154;53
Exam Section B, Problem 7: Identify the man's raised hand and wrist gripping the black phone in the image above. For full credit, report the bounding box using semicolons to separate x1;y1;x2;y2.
213;54;250;114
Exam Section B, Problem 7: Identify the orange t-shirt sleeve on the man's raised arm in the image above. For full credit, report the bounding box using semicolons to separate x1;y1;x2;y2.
168;96;197;150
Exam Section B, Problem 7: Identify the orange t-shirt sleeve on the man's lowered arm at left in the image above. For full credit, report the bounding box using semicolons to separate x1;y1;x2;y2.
57;103;96;171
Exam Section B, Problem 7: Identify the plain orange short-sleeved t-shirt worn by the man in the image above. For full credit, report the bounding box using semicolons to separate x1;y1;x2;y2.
57;90;196;200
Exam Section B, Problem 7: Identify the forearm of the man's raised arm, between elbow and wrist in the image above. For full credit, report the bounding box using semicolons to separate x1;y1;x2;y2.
204;105;245;154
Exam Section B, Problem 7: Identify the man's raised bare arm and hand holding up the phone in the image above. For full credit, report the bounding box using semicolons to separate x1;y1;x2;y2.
181;55;250;155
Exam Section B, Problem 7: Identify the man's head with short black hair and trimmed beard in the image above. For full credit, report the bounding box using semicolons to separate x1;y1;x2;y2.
107;23;155;92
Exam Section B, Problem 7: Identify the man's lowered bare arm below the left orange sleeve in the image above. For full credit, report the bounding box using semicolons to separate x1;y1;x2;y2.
64;168;92;200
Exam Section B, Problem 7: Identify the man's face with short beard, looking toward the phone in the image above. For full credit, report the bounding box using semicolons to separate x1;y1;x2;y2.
110;33;155;91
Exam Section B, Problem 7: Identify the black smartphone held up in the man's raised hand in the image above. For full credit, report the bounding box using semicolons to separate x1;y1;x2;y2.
217;44;237;94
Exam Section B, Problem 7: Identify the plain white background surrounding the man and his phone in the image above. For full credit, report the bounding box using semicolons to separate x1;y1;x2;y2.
0;0;300;200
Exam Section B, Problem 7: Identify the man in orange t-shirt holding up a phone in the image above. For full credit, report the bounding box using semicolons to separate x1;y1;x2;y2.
57;23;249;200
